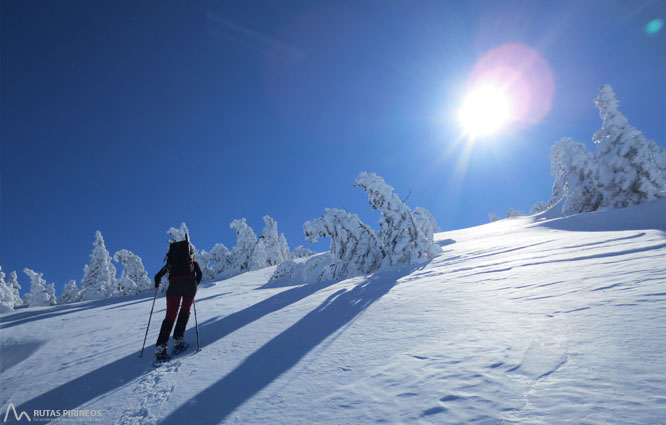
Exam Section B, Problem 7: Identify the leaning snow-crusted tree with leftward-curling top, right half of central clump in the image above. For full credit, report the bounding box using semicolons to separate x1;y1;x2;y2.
354;172;441;265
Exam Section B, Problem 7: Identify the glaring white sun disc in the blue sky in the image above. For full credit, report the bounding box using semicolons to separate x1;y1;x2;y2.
458;84;513;138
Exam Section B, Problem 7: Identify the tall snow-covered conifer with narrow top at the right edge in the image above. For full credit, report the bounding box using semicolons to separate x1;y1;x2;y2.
593;85;666;208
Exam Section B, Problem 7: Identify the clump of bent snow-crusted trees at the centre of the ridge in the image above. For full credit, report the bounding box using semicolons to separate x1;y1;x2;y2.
271;173;441;282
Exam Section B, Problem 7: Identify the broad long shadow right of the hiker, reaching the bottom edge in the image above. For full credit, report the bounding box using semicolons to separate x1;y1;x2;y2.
161;273;399;425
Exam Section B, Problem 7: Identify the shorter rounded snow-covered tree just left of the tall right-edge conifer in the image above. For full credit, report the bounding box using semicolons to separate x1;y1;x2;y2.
548;137;603;214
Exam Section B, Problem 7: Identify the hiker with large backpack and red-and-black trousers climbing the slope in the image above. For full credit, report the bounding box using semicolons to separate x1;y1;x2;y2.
155;238;201;361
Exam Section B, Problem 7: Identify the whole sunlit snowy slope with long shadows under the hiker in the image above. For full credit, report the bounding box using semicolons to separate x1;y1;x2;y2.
0;200;666;424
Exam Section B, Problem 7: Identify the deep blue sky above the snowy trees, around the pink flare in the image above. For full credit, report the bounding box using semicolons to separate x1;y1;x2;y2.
0;0;666;293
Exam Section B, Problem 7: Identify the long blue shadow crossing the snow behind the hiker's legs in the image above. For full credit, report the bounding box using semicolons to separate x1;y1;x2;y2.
10;282;334;423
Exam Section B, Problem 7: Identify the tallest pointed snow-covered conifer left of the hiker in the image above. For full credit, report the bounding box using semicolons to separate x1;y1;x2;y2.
81;230;117;301
